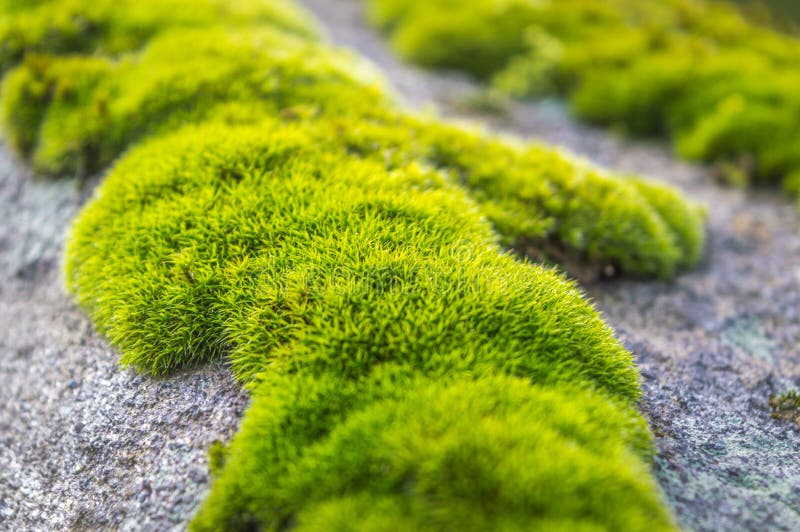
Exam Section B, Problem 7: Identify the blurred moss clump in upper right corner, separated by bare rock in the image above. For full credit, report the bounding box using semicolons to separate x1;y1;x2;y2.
368;0;800;198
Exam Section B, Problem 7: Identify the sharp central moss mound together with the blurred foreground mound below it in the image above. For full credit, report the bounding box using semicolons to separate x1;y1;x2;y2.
61;124;671;530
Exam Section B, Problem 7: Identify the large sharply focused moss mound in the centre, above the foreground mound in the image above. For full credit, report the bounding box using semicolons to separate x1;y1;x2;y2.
66;121;636;397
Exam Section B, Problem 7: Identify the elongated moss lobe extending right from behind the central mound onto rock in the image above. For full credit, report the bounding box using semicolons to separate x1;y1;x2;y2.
326;119;705;277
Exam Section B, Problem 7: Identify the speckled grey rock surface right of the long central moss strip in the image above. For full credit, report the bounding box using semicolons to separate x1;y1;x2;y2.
305;0;800;531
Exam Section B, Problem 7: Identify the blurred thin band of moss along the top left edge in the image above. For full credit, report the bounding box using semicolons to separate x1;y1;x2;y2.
0;0;317;73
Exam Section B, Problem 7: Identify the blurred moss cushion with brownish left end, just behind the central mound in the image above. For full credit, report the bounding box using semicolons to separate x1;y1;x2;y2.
2;26;389;174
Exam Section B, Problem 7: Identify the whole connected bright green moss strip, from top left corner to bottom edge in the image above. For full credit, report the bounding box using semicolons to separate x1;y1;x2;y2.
0;0;703;530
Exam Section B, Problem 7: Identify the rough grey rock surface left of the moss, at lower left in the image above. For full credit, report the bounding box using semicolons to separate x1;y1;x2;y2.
0;146;246;531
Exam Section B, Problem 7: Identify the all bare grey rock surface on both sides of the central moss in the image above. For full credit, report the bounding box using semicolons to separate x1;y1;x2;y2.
0;0;800;530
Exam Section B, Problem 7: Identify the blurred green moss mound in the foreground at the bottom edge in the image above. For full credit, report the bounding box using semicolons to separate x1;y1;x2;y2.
192;368;671;530
